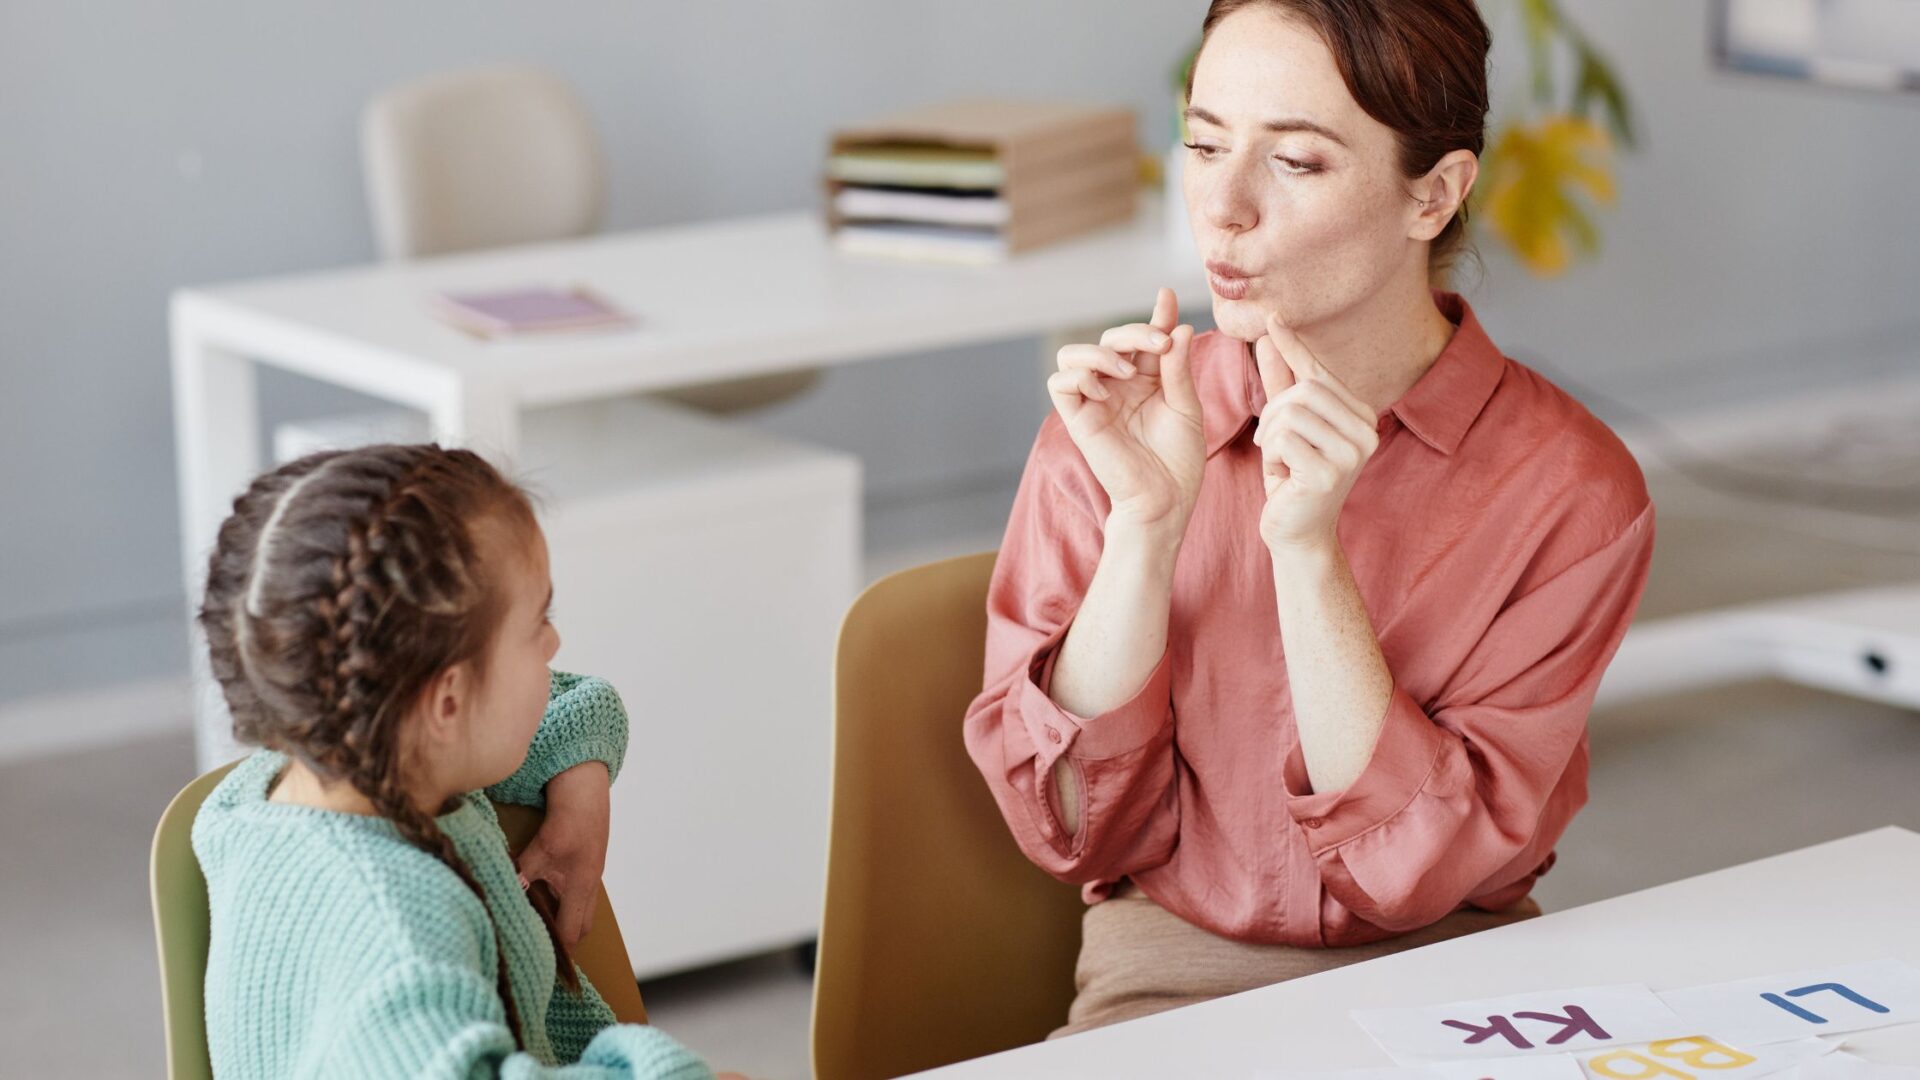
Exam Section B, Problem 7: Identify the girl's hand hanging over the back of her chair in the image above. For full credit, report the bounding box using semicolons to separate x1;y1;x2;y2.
516;761;612;949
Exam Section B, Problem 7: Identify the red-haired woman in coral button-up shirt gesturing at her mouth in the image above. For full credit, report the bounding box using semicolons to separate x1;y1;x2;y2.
966;0;1653;1034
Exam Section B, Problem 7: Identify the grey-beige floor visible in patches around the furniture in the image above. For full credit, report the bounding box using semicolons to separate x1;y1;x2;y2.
0;465;1920;1078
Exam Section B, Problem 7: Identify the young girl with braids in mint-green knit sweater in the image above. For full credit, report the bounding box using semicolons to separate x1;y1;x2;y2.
194;446;712;1080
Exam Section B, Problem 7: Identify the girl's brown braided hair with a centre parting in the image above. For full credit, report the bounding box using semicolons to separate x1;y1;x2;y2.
200;446;580;1045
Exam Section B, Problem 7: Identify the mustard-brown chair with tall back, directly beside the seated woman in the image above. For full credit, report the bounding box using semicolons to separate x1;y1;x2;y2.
814;553;1085;1080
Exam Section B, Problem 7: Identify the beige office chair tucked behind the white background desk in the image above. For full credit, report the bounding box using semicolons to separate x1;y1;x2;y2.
361;67;820;413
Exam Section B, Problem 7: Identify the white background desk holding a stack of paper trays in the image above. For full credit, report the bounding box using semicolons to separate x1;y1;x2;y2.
171;196;1208;765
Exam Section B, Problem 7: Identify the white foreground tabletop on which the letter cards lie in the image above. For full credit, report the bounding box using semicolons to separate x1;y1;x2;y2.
922;826;1920;1080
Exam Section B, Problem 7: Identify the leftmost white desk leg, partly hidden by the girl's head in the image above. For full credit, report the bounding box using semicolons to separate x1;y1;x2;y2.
173;311;259;771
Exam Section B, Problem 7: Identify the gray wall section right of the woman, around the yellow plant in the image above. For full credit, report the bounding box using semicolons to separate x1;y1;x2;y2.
1476;0;1920;409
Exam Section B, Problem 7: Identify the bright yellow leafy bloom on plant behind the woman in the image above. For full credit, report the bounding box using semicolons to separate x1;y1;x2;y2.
1475;113;1613;277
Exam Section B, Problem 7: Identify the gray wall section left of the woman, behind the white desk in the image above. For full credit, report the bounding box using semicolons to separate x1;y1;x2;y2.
0;0;1198;700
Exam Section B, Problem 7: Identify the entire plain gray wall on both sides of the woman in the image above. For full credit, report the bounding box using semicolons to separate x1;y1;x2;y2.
0;0;1920;701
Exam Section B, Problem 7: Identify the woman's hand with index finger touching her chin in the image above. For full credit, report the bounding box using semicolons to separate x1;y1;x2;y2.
1254;315;1380;555
